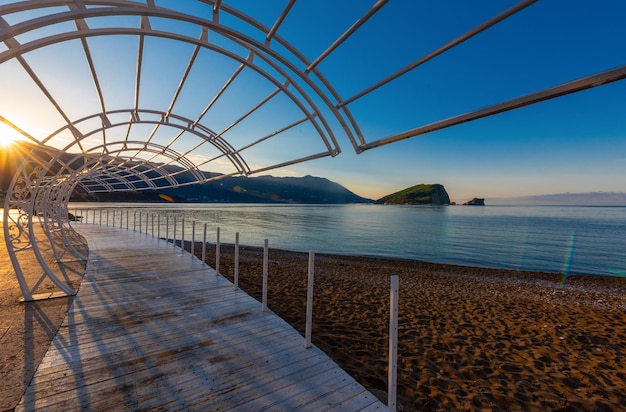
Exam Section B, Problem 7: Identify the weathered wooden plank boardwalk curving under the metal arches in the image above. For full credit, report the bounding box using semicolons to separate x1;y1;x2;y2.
16;225;386;411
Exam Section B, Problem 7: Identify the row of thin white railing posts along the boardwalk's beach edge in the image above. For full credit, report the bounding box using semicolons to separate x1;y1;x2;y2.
74;208;399;411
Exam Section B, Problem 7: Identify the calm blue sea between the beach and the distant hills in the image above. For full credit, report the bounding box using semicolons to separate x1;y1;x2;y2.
70;203;626;276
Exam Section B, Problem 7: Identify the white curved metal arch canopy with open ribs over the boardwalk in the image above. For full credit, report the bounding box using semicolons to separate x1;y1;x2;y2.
0;0;626;300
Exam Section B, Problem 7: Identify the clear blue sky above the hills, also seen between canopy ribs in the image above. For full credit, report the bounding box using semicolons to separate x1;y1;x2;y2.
0;0;626;202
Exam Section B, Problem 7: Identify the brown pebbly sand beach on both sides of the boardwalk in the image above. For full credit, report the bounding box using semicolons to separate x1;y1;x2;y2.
0;227;626;411
